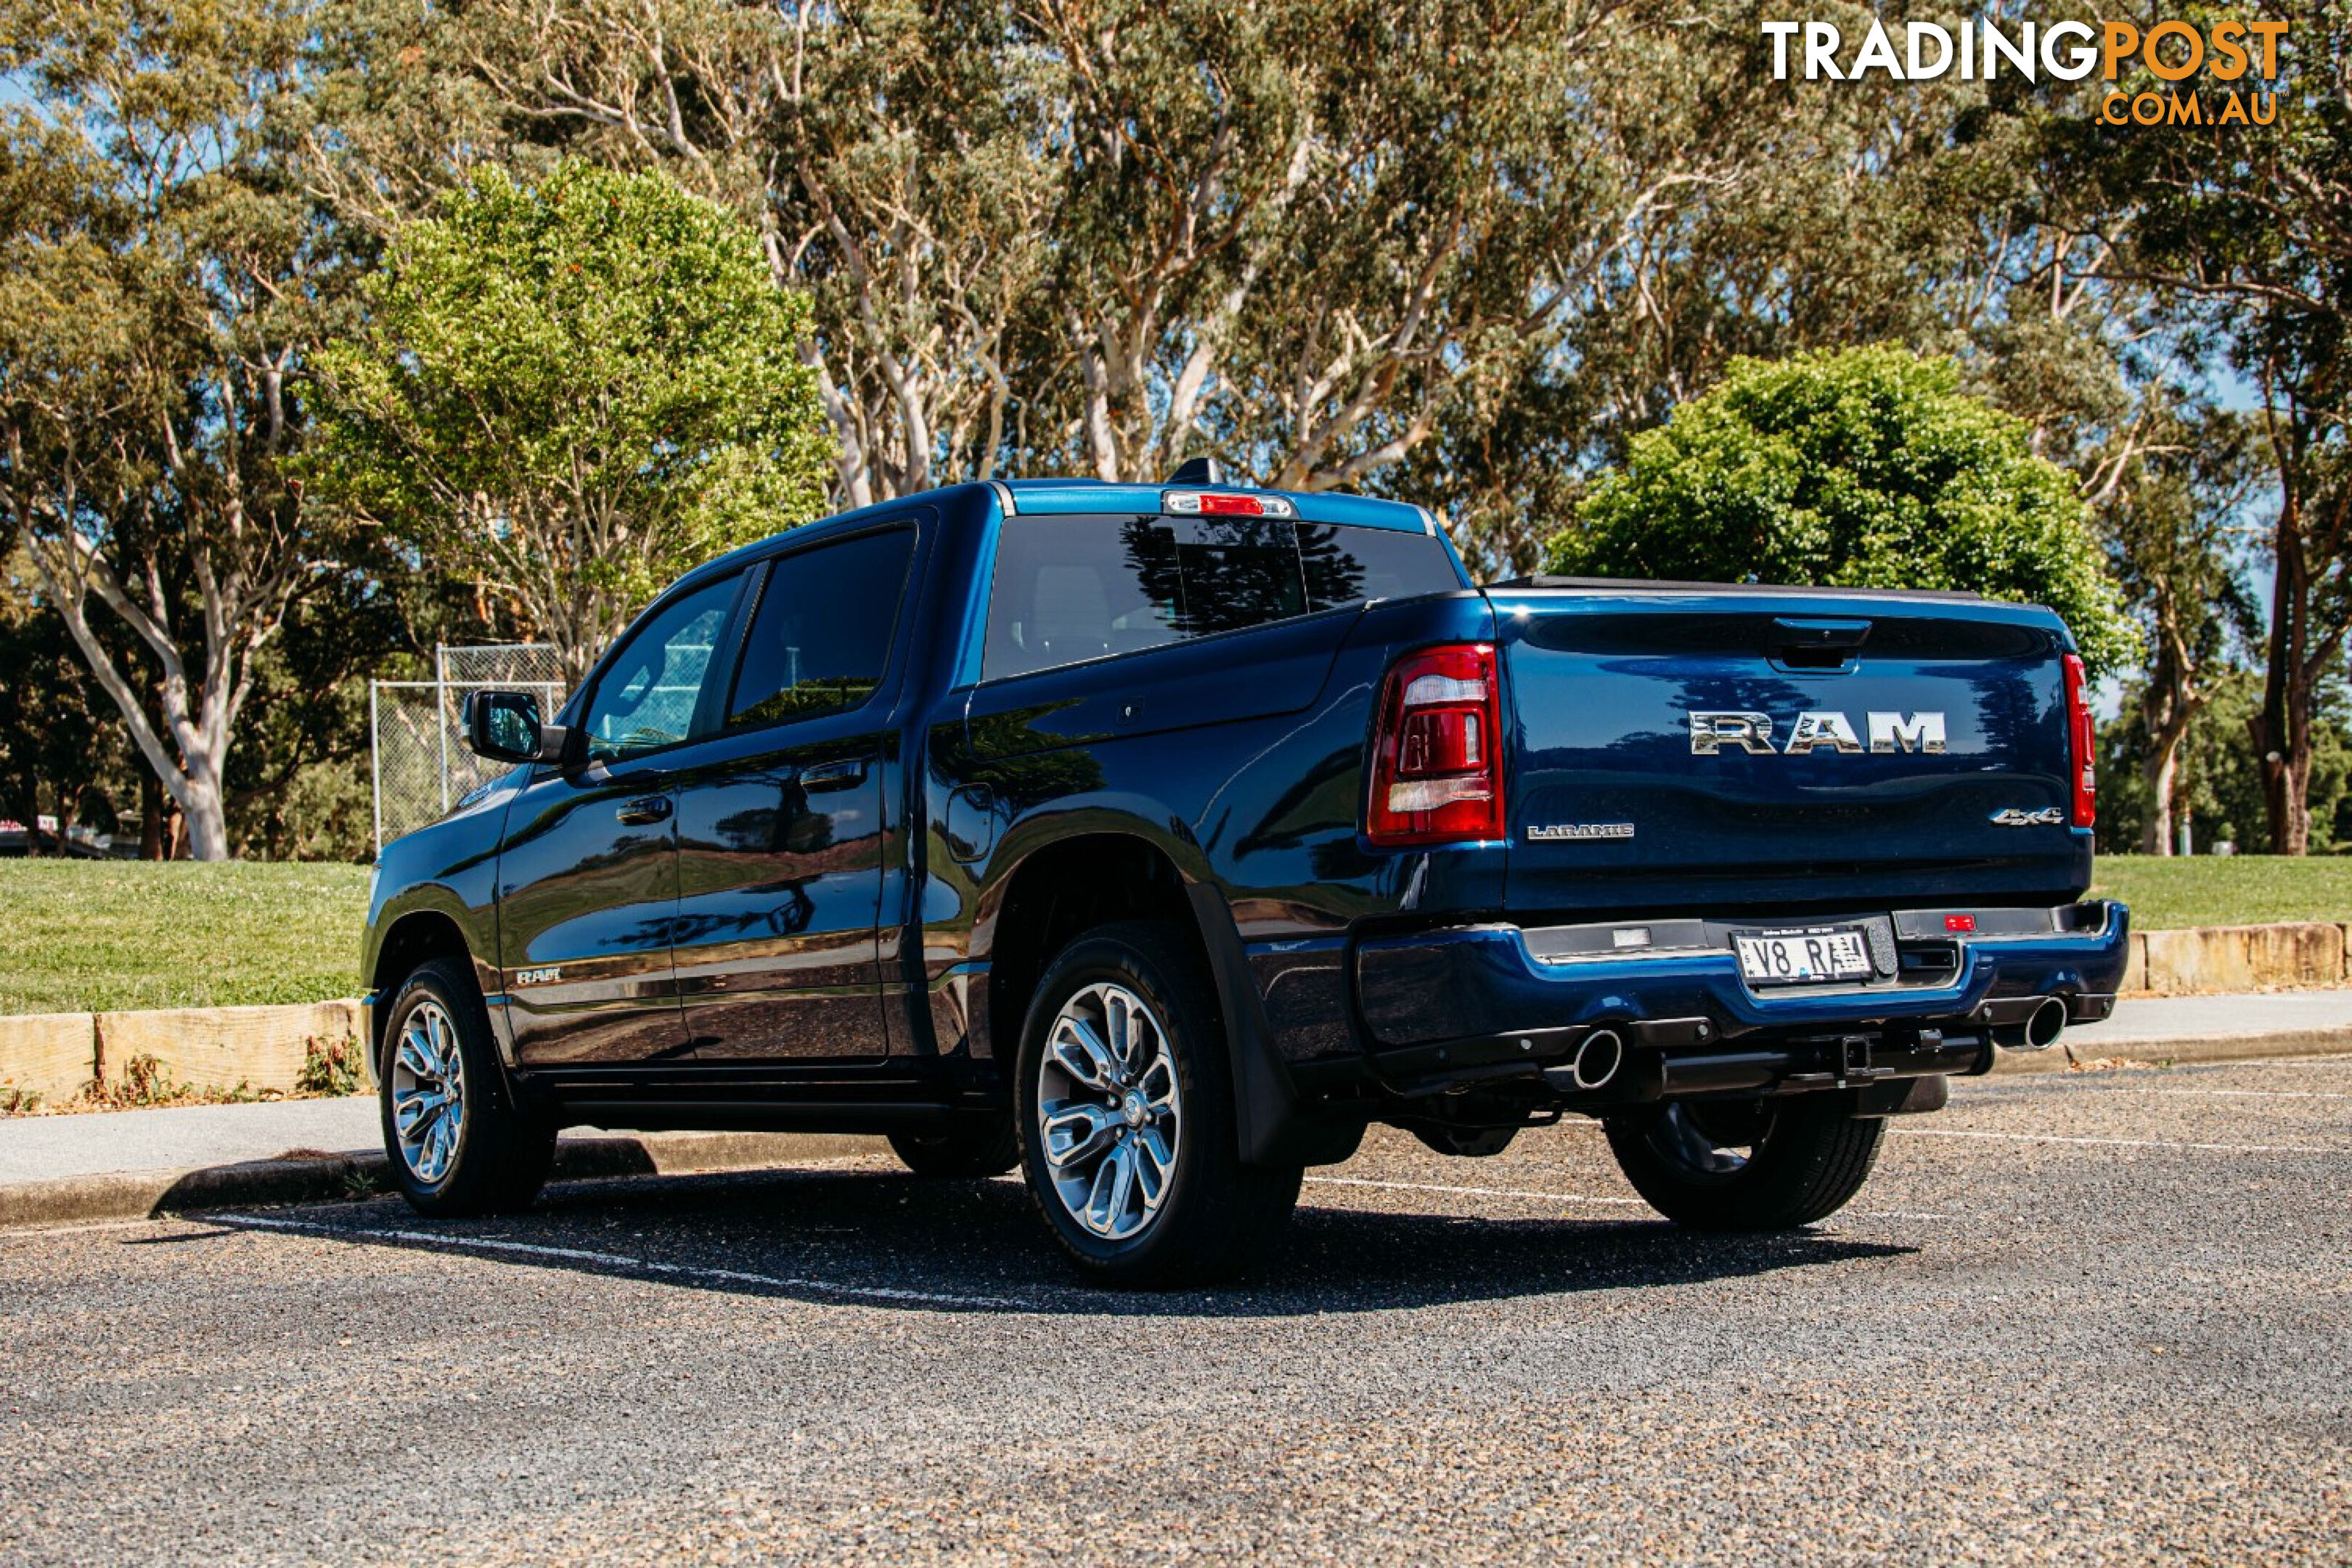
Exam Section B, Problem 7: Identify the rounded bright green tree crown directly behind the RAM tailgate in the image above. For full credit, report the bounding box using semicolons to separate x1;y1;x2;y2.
1550;346;2136;670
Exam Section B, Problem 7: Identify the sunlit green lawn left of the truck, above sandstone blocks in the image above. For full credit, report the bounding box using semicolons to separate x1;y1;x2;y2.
0;860;367;1013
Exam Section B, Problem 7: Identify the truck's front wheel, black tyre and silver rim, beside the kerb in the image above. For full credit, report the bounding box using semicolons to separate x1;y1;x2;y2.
376;959;555;1215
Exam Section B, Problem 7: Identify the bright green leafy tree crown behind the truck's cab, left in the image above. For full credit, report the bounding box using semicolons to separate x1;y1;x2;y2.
308;162;833;674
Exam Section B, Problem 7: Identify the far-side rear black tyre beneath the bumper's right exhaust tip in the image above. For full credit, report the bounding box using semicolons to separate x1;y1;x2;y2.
1606;1095;1886;1232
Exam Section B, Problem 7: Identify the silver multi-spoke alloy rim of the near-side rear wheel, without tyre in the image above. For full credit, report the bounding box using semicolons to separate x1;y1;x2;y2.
1037;983;1183;1241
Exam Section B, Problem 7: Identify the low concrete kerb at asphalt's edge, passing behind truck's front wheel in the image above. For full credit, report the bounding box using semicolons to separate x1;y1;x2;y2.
0;1133;889;1230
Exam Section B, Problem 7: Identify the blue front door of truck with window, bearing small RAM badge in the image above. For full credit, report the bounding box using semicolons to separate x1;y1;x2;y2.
499;573;743;1065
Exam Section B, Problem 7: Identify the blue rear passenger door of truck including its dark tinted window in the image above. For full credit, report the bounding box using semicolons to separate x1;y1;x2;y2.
675;520;915;1065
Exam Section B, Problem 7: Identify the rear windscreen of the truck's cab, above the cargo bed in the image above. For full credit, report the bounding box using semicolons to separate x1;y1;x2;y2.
981;517;1461;679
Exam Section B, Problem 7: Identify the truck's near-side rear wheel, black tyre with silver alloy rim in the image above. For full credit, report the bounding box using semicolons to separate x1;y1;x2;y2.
1018;921;1301;1289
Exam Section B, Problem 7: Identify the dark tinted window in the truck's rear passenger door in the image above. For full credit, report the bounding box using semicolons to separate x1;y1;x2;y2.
727;529;915;729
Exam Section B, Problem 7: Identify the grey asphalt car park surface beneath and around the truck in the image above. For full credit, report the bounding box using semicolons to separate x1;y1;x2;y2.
0;1058;2352;1564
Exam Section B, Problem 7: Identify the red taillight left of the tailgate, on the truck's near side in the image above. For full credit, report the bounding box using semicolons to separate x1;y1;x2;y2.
1364;642;1503;849
